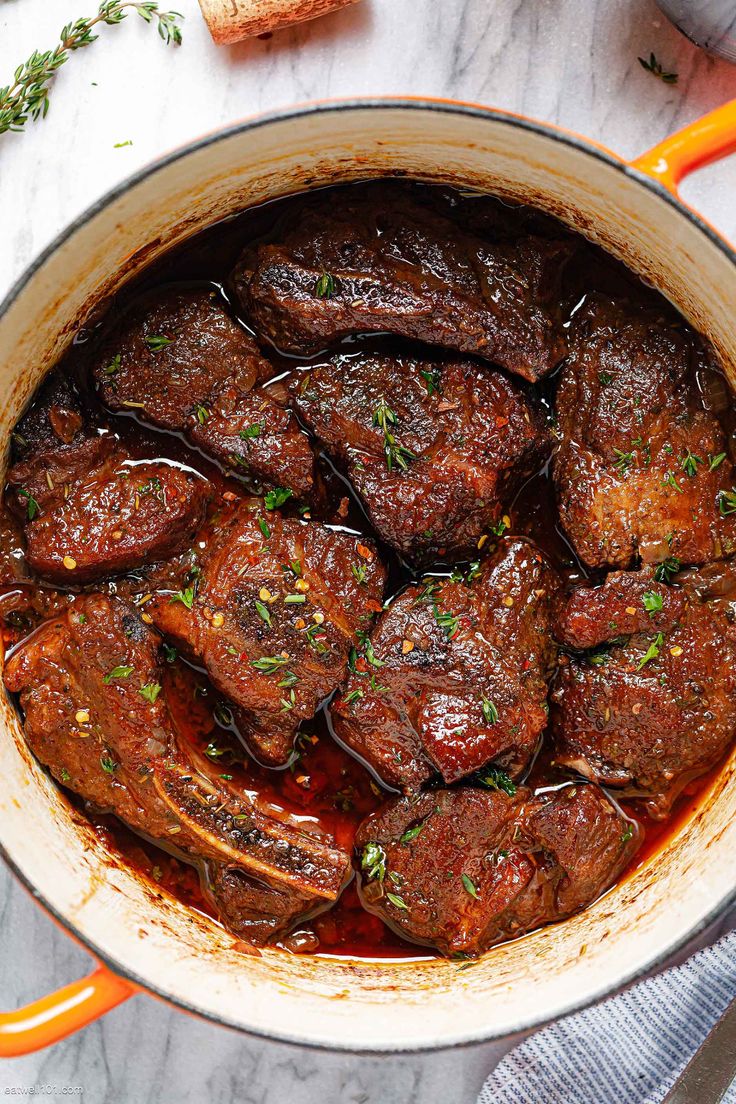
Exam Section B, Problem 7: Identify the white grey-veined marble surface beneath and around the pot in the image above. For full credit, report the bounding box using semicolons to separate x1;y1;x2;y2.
0;0;736;1104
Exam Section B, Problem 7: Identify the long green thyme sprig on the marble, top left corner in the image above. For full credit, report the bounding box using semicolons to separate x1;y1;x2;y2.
0;0;184;134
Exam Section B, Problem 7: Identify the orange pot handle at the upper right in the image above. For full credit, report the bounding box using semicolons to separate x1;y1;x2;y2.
631;99;736;195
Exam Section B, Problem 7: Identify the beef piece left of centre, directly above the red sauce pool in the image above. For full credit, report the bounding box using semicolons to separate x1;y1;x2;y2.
146;501;384;765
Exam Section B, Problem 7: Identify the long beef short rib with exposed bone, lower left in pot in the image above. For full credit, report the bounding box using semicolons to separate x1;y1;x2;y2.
4;594;350;942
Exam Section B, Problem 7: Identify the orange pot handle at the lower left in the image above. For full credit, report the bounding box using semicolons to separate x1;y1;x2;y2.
0;966;137;1058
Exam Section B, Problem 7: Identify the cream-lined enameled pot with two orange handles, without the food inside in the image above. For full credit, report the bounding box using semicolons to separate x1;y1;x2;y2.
0;99;736;1057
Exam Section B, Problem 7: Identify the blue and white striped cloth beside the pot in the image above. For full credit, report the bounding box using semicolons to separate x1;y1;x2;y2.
478;932;736;1104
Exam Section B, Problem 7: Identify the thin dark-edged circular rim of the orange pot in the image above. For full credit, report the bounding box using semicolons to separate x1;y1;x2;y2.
0;96;736;1055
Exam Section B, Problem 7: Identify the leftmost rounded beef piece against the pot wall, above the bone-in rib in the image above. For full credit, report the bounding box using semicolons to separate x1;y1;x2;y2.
8;376;210;584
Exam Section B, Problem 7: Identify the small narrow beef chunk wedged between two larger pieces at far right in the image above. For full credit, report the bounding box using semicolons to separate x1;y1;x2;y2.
553;567;687;650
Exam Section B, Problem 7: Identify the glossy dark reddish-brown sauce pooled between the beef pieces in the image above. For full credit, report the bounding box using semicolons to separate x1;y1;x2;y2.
0;181;734;958
